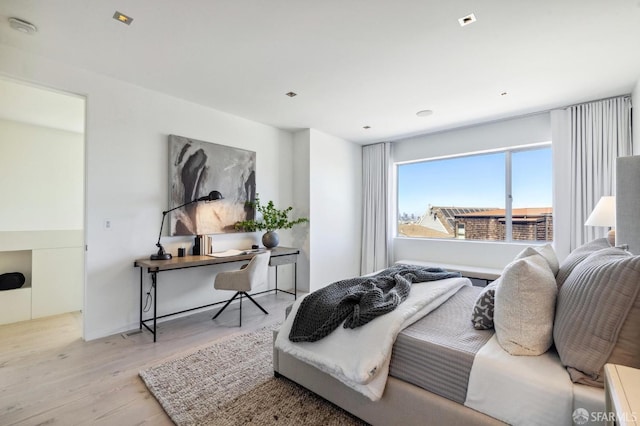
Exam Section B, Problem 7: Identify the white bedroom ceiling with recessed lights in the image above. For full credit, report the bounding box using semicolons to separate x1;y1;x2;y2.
0;0;640;143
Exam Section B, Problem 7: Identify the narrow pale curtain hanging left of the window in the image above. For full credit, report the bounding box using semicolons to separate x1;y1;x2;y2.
360;142;391;274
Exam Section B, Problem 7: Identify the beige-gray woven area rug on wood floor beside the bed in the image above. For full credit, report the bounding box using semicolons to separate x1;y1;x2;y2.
140;327;366;426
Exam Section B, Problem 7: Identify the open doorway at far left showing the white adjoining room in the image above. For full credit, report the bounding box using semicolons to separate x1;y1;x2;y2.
0;77;86;335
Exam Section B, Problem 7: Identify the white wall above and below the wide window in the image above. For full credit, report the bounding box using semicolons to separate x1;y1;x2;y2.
393;113;557;268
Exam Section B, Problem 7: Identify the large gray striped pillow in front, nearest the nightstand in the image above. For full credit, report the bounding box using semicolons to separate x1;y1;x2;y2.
553;247;640;387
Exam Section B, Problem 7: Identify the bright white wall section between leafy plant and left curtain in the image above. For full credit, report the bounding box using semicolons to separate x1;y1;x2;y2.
295;129;362;291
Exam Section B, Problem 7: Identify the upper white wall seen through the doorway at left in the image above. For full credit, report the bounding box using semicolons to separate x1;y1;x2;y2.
0;119;84;231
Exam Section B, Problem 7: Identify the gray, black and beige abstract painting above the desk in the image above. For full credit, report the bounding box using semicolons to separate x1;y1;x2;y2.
169;135;256;235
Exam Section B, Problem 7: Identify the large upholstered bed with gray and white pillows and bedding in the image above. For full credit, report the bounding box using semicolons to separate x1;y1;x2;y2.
273;238;640;426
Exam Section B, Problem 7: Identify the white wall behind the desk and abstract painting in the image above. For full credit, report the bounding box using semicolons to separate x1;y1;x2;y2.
0;46;293;339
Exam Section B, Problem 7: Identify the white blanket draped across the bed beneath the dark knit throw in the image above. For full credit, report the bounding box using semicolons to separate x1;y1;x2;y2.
275;278;471;401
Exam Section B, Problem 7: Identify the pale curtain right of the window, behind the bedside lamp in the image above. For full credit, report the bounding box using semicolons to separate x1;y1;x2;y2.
554;96;633;250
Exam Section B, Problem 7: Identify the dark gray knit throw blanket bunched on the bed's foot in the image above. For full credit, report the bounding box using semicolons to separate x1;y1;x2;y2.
289;264;460;342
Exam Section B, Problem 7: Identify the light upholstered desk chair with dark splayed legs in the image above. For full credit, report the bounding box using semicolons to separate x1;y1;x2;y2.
211;252;271;327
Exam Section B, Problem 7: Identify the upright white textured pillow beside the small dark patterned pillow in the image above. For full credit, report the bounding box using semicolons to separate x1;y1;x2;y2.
493;254;558;355
